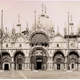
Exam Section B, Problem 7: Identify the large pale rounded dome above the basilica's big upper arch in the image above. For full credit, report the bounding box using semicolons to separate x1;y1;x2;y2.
32;13;54;30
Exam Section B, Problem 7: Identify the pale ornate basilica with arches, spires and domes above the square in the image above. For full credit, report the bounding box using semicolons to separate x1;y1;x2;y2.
0;4;80;70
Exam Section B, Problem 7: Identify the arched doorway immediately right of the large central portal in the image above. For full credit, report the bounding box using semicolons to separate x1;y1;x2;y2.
53;51;65;70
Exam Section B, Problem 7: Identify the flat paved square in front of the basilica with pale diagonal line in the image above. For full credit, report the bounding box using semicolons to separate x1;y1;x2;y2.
0;70;80;79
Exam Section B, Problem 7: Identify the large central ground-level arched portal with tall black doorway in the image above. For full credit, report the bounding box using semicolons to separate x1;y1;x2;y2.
30;48;47;70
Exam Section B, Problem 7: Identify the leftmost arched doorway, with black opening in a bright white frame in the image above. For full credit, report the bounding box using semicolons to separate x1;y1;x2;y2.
2;52;10;70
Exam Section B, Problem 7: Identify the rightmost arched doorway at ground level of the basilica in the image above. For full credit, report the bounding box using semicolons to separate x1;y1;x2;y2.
68;52;79;70
